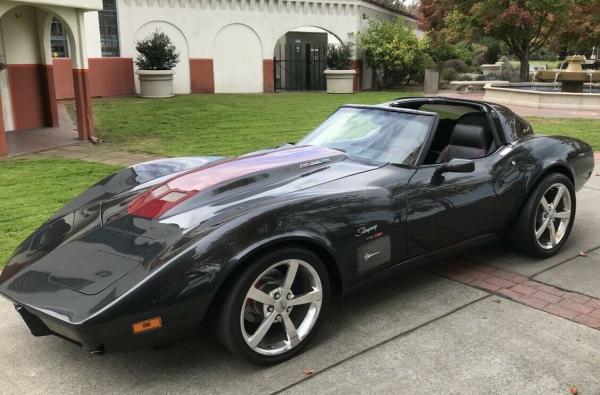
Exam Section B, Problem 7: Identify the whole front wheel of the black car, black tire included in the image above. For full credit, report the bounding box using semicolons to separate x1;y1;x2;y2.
215;248;330;365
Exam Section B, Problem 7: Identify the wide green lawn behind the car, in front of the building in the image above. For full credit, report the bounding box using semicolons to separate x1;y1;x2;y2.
94;92;416;156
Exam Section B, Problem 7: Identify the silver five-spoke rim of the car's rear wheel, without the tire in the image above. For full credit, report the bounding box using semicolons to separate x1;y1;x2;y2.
534;183;571;250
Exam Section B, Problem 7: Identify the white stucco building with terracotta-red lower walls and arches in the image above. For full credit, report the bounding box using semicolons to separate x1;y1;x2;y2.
0;0;416;157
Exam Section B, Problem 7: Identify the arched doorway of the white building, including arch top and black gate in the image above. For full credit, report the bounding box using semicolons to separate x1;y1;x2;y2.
273;26;342;91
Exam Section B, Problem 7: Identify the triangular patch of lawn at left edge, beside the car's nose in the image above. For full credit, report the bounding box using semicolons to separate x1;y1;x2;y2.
0;159;118;267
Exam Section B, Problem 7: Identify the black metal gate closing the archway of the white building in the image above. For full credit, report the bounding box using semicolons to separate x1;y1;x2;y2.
273;42;327;91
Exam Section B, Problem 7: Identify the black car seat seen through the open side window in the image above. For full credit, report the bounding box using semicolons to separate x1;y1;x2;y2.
436;123;492;163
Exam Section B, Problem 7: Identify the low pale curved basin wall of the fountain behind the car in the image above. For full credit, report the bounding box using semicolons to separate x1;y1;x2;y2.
483;83;600;111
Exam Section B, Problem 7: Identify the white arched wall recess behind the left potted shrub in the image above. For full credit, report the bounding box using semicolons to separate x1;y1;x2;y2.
132;19;191;94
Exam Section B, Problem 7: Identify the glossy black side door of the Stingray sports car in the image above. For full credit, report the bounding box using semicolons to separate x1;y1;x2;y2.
407;146;525;257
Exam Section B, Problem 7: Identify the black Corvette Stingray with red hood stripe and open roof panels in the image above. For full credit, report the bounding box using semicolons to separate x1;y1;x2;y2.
0;98;594;364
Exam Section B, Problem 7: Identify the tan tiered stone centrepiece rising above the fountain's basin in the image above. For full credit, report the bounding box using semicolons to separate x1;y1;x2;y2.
535;55;600;93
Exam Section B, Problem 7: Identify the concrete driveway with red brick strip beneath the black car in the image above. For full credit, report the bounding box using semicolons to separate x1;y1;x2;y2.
0;163;600;394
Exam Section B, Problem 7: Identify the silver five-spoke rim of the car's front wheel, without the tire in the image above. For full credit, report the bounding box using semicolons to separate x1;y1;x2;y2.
240;259;323;355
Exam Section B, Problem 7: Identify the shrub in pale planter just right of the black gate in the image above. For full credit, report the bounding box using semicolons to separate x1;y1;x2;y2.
325;44;356;93
